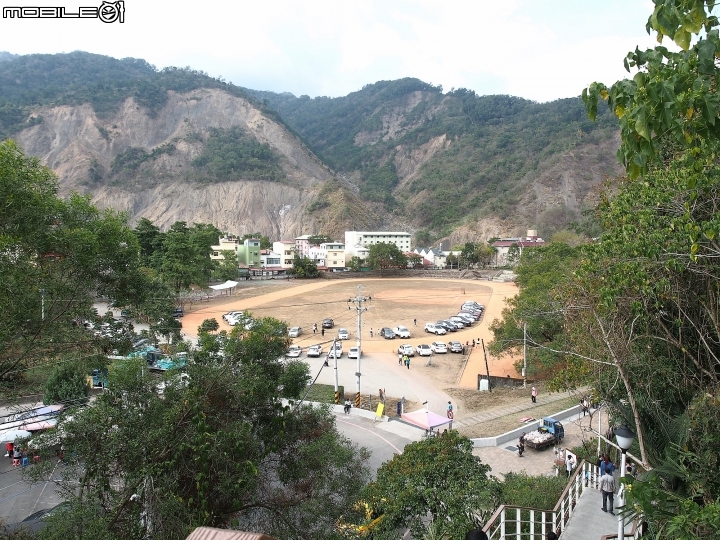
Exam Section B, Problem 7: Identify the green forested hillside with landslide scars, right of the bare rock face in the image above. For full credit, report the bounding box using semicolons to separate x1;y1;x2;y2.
248;79;617;235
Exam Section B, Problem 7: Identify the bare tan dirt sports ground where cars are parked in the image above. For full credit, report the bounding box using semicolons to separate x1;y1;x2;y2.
182;278;558;431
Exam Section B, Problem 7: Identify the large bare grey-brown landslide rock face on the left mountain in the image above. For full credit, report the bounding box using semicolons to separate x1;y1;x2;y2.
18;89;360;238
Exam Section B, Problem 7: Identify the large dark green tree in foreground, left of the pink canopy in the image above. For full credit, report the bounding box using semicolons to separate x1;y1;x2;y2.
31;319;368;540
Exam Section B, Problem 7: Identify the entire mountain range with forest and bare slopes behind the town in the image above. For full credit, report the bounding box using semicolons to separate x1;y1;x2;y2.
0;52;620;243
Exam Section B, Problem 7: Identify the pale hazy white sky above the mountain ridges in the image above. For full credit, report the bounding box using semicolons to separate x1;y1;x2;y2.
0;0;654;101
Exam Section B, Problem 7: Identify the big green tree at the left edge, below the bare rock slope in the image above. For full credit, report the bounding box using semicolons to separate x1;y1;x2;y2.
0;140;150;384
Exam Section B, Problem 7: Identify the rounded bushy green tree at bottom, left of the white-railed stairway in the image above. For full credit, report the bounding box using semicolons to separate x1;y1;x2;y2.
363;430;500;540
